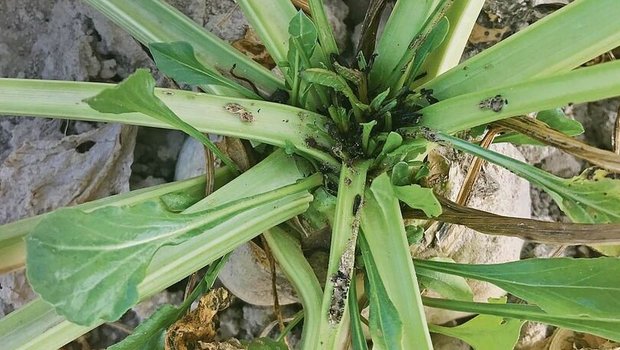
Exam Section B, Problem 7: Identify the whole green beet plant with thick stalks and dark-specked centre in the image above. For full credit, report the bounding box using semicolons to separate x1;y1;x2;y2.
0;0;620;349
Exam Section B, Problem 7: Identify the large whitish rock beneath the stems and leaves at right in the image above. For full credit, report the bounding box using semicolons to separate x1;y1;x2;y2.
412;144;531;324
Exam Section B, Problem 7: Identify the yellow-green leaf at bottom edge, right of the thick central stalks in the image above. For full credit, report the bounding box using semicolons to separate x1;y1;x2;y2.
428;306;525;350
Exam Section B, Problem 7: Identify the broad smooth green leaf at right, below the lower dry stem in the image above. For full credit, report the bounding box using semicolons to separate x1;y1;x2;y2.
415;258;620;319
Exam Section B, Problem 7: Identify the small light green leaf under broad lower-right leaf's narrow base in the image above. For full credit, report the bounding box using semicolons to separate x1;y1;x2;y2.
415;258;474;301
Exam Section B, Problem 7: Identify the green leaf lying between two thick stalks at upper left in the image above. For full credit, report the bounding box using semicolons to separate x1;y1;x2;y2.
149;41;262;99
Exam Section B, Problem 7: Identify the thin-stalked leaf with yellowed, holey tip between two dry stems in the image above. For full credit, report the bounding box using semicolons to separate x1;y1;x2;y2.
430;133;620;224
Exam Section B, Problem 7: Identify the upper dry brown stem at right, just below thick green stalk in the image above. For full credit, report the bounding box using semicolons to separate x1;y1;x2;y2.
493;117;620;172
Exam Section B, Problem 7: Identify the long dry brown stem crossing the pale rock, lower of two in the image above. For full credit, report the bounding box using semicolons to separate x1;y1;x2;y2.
403;196;620;245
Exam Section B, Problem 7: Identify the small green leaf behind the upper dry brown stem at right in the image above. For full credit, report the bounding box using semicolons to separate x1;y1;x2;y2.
493;108;584;145
